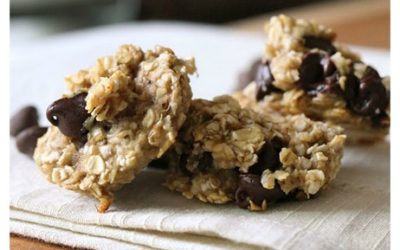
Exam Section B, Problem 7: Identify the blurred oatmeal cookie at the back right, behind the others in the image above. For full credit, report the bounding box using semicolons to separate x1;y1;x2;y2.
233;15;390;142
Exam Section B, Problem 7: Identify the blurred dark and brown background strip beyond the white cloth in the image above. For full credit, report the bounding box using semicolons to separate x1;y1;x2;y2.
10;0;390;48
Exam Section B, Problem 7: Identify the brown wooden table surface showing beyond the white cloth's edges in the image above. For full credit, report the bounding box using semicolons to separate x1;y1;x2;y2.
10;0;390;250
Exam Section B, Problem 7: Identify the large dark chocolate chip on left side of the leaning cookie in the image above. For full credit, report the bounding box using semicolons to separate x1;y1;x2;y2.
47;93;89;139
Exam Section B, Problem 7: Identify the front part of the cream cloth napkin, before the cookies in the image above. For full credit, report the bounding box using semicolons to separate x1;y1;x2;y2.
10;140;390;249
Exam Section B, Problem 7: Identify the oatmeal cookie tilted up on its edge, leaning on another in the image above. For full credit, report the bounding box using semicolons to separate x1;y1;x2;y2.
34;45;196;212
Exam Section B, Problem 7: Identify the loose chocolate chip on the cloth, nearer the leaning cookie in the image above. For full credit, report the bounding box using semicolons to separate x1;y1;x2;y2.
16;126;47;156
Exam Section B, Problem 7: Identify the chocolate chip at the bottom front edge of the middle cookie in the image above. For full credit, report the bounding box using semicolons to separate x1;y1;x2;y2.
235;174;286;208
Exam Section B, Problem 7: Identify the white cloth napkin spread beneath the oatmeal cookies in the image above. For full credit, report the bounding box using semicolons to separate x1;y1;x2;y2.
10;23;390;250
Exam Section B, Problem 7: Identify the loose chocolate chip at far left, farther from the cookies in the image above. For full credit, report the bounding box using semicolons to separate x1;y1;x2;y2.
10;106;38;136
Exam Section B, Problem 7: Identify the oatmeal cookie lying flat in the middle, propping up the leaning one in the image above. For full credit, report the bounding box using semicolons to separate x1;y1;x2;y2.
165;96;346;210
